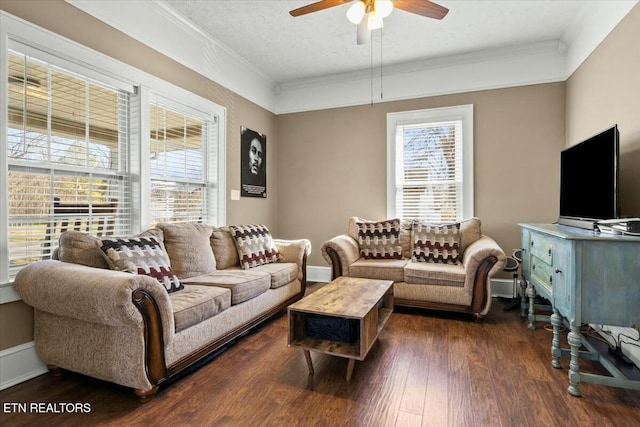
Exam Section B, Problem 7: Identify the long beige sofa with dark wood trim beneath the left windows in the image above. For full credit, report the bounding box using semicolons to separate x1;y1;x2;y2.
15;224;311;402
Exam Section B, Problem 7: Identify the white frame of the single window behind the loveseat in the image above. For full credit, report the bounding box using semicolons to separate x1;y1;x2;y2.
387;104;474;220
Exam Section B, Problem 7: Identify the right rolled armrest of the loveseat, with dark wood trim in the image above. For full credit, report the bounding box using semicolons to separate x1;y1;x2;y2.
462;235;507;316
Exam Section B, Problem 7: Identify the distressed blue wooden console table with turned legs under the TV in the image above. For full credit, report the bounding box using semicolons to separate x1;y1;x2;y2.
519;224;640;396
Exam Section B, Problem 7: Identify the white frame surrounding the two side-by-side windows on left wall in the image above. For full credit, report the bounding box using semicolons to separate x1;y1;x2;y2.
0;11;227;304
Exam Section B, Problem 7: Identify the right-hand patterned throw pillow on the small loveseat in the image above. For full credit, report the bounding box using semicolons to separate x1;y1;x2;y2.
411;222;460;264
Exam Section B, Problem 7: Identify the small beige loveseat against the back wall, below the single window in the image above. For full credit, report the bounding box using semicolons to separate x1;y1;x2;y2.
321;217;506;321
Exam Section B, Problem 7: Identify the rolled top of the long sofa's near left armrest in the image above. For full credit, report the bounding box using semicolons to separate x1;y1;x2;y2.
14;260;175;344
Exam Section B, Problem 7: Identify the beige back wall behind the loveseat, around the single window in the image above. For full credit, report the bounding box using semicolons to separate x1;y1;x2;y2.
277;83;565;266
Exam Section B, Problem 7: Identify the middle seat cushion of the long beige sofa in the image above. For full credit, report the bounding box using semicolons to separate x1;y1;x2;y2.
183;269;271;305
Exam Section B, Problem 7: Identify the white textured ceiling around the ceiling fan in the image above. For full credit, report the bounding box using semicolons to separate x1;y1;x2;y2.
161;0;596;83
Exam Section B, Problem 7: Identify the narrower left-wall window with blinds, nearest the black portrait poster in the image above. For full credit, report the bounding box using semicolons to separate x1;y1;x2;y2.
149;101;217;225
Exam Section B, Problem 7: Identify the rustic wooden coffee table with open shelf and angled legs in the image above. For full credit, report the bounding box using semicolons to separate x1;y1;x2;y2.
287;277;393;381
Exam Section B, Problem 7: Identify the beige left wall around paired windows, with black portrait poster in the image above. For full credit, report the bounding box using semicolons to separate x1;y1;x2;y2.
0;0;277;350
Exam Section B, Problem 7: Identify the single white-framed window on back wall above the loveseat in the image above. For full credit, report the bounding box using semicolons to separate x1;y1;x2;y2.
387;105;473;222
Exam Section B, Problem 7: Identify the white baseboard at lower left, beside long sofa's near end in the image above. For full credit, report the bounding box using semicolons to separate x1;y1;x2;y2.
0;341;48;390
